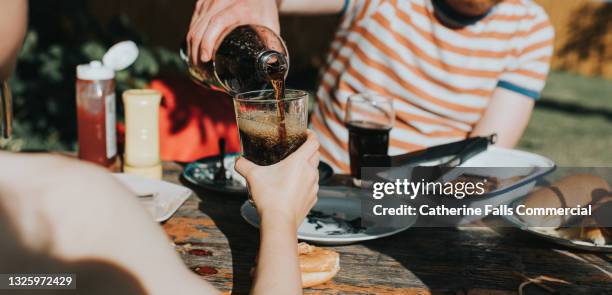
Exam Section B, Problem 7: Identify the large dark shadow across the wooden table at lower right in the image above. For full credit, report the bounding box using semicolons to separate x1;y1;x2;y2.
363;221;612;294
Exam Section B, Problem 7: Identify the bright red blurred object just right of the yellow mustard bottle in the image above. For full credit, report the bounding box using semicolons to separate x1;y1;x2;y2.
151;78;240;162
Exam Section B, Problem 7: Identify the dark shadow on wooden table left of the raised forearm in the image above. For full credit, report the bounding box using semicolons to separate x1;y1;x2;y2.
180;177;259;294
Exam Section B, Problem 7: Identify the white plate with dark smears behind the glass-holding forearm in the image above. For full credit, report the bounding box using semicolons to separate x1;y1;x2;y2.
240;187;417;245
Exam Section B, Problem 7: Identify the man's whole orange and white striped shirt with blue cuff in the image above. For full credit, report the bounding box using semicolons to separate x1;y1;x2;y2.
311;0;554;172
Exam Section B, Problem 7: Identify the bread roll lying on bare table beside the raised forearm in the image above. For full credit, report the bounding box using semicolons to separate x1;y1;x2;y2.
298;243;340;288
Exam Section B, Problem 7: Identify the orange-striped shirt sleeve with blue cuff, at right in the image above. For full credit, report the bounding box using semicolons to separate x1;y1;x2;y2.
497;7;555;99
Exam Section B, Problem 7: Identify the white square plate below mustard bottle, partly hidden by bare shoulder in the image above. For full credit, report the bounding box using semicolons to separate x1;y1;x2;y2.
113;173;192;222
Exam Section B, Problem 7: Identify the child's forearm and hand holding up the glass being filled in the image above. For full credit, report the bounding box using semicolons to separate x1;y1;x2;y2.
236;132;319;294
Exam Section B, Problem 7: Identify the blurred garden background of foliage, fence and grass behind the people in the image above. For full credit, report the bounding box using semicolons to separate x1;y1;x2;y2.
0;0;612;166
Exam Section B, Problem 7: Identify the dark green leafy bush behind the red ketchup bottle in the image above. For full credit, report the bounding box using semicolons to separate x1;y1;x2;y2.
5;0;183;154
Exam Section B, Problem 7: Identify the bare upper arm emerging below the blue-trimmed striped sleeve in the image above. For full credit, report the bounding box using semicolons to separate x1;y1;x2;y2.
471;87;534;148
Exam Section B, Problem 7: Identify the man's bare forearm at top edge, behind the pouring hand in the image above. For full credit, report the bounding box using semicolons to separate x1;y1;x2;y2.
277;0;346;14
